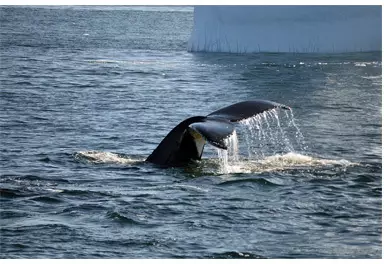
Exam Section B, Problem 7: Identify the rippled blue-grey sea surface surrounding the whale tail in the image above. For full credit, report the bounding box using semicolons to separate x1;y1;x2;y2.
0;6;382;258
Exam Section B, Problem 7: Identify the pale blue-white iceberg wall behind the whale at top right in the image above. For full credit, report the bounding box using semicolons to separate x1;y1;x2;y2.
188;6;382;53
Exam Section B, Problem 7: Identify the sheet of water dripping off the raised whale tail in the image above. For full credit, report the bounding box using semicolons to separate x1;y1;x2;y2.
217;109;307;173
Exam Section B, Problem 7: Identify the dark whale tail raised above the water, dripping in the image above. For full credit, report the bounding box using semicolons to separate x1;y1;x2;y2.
146;100;291;167
